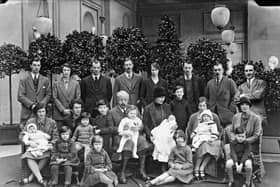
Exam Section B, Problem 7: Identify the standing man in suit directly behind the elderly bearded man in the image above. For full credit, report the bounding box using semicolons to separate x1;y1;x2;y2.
113;58;143;106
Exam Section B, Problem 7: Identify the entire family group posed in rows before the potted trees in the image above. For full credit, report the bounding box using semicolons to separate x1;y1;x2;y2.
18;58;266;187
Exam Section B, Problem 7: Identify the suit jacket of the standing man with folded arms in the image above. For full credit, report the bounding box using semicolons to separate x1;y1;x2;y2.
238;78;266;119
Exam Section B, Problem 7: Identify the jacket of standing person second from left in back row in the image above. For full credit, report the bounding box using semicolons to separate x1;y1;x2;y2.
53;79;81;120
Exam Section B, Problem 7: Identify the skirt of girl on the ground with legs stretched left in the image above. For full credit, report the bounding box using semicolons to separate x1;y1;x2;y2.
167;167;193;184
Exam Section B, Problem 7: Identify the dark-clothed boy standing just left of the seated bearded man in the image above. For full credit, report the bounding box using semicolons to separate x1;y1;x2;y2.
93;99;112;155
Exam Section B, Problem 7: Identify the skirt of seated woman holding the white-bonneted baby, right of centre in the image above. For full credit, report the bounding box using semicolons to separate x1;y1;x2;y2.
195;140;222;160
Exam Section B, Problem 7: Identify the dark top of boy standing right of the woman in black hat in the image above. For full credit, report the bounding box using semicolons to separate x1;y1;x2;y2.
170;98;192;132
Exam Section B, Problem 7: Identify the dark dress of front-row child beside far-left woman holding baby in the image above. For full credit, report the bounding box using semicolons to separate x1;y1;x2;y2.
50;139;80;166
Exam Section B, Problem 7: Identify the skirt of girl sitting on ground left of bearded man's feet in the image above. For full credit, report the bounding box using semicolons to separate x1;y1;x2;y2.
81;171;118;187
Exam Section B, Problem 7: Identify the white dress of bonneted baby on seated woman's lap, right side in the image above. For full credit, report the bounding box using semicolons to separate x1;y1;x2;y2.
191;120;219;149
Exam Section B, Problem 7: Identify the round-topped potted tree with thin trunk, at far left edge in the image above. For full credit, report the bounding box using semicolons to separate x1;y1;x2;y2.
0;44;27;144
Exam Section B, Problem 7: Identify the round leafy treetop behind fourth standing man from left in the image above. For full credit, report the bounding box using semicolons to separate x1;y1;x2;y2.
105;27;150;75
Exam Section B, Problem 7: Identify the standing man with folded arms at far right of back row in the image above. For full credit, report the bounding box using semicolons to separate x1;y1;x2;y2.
237;63;266;124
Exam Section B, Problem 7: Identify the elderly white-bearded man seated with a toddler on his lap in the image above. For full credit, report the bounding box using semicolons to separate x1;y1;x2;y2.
107;90;150;184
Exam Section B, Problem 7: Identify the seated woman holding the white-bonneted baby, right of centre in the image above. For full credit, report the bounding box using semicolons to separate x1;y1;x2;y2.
186;97;222;179
